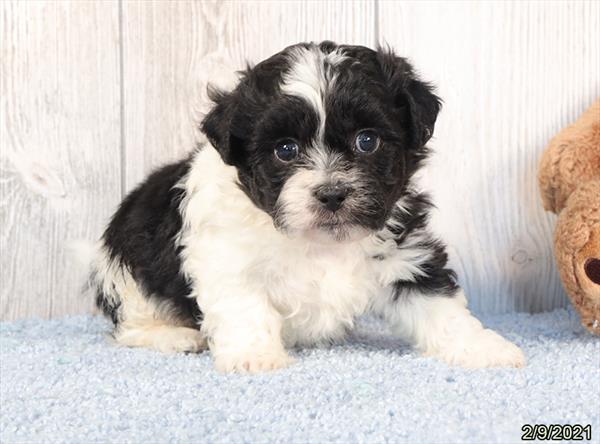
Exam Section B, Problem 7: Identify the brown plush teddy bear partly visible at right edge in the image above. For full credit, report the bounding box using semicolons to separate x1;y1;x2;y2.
539;100;600;334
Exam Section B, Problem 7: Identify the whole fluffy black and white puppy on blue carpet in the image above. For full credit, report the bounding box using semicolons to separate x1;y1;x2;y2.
93;42;525;372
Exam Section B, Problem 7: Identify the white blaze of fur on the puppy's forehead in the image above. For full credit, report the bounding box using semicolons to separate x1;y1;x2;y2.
281;46;346;138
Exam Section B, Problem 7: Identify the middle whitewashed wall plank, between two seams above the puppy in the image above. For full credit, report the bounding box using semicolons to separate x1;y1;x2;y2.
123;0;375;189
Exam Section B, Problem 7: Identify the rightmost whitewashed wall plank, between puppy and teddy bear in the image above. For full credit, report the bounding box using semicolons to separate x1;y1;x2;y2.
378;1;600;313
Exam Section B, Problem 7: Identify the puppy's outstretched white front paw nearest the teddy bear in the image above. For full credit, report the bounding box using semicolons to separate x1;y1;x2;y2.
431;329;526;368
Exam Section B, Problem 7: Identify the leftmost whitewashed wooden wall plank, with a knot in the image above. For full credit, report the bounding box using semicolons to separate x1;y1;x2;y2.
0;1;121;319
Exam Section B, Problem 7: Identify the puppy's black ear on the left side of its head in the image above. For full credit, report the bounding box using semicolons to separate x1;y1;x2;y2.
200;86;242;165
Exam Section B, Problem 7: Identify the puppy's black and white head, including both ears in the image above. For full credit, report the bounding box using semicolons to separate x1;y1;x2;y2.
202;42;440;241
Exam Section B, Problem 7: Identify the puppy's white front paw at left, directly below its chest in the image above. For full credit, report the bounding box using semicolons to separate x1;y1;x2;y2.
215;351;294;373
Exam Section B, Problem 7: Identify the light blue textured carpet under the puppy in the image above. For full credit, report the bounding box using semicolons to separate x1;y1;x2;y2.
0;310;600;444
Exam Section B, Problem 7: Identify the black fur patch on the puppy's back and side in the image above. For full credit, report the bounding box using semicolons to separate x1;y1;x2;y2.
97;159;202;323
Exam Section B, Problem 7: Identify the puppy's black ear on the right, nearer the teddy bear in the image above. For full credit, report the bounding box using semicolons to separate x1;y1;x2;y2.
377;47;442;148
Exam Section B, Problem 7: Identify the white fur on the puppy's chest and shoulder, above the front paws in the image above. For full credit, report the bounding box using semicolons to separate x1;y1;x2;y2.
179;147;386;345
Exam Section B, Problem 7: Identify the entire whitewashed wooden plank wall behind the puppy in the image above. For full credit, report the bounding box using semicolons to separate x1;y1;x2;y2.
0;0;600;319
